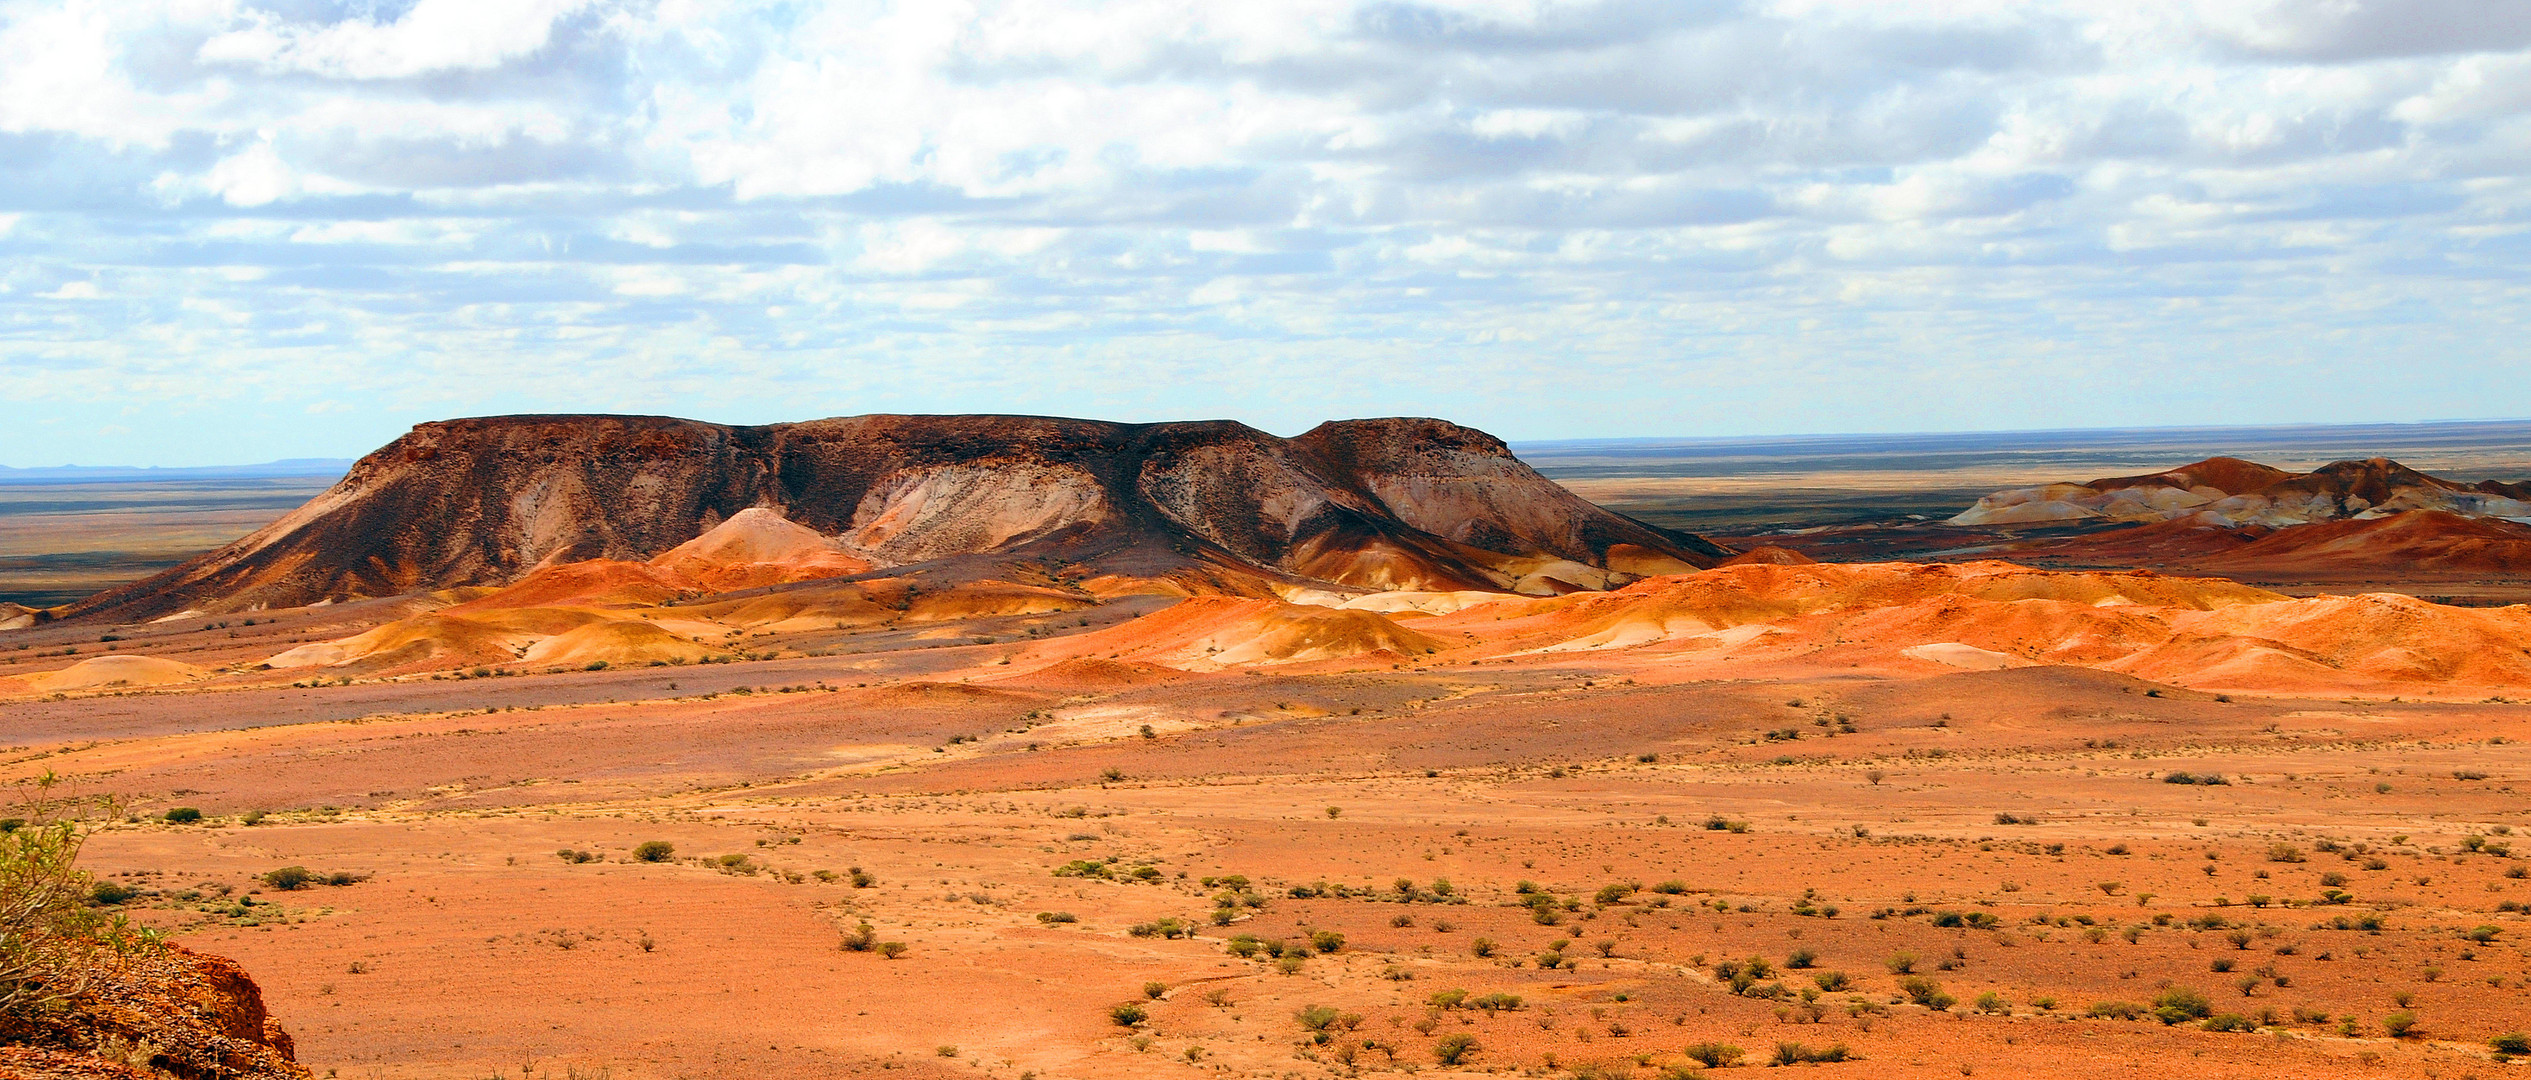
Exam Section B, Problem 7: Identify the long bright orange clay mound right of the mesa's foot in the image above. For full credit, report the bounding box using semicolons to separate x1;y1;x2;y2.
1417;561;2531;693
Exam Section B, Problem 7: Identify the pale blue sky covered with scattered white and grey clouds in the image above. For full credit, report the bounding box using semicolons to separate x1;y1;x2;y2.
0;0;2531;465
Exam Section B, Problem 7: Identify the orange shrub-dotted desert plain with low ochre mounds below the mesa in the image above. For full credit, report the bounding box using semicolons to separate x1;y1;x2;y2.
0;548;2531;1080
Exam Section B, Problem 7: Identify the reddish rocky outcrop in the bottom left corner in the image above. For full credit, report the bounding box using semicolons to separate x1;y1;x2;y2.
0;946;309;1080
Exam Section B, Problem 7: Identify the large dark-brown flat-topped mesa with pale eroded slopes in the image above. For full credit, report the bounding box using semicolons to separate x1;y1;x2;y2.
63;415;1729;620
